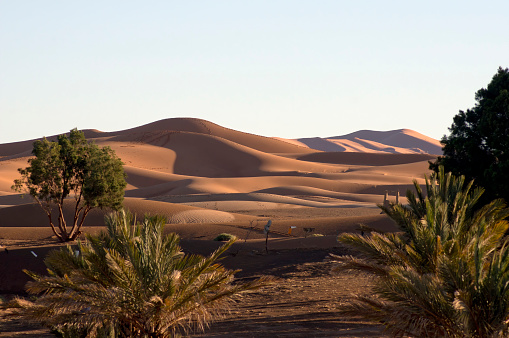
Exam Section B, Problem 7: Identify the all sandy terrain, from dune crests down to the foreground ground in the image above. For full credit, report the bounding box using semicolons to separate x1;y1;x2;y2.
0;118;440;337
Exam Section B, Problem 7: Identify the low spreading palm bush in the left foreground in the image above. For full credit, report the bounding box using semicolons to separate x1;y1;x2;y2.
7;211;270;337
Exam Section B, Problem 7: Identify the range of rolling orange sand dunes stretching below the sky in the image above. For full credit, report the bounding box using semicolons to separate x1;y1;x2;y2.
0;118;439;241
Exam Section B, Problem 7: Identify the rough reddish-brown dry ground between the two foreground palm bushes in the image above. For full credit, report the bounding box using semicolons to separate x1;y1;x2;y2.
0;238;383;338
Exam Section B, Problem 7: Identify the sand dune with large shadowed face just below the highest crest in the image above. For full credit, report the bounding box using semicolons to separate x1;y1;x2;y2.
102;131;346;177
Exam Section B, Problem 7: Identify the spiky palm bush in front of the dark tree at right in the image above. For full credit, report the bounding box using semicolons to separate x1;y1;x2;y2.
335;167;509;337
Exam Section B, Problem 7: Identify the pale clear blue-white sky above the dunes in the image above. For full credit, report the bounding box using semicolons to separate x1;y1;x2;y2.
0;0;509;143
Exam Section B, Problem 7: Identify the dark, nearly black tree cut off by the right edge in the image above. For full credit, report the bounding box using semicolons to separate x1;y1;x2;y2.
430;68;509;201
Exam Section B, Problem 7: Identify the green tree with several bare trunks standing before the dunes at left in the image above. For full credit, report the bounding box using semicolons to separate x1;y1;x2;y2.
12;129;126;242
